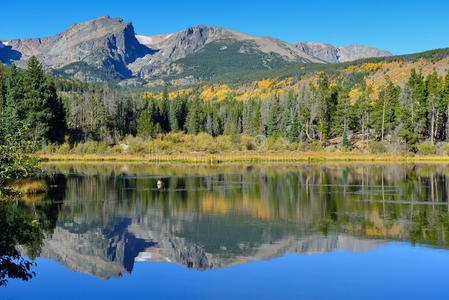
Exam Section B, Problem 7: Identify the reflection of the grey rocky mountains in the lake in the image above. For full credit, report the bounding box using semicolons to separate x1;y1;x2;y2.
28;214;384;279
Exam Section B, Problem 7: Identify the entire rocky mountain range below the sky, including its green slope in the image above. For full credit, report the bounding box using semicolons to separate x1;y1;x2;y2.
0;16;391;83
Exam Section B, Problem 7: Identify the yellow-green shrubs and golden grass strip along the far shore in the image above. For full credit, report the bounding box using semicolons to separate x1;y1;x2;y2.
36;132;449;164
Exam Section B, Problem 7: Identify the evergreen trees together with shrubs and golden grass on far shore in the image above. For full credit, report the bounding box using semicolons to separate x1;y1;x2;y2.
0;57;449;163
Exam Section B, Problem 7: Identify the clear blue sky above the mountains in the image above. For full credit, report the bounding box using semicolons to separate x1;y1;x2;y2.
0;0;449;54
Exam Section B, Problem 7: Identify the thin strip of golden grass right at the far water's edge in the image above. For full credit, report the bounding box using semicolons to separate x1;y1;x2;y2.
38;151;449;164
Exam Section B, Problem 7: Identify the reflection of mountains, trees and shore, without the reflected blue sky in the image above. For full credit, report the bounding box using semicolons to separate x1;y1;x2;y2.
7;164;449;279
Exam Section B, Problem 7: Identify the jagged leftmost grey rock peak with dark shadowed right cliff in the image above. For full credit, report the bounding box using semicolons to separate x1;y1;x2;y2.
0;16;152;79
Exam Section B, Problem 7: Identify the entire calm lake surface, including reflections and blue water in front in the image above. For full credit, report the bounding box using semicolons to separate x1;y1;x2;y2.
0;164;449;299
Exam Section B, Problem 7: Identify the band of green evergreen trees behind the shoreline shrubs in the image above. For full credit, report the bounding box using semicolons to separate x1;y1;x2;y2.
0;58;449;151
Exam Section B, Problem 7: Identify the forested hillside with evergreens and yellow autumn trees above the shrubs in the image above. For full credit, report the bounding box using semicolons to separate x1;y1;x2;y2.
0;49;449;153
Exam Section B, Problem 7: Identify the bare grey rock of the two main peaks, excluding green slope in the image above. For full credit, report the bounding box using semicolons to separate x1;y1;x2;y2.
0;16;322;81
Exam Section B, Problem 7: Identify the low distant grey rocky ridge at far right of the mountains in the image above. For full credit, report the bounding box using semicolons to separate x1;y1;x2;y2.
292;42;392;63
